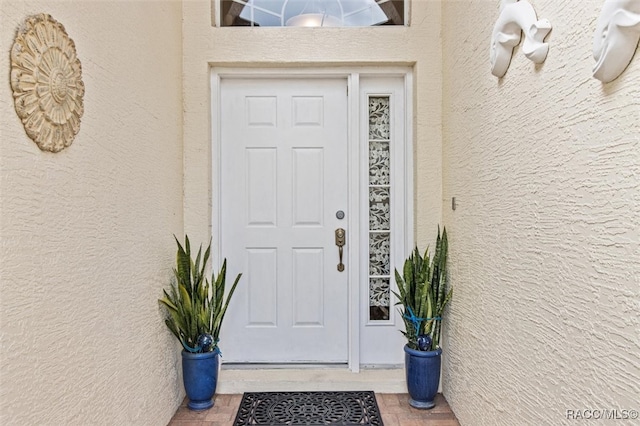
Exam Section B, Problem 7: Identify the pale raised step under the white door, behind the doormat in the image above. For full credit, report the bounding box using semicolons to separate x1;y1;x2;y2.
216;364;407;394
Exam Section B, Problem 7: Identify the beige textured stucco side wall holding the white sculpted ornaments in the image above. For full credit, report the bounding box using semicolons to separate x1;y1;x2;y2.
443;0;640;426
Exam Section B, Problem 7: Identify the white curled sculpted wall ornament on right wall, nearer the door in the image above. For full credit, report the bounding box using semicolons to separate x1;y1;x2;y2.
490;0;551;78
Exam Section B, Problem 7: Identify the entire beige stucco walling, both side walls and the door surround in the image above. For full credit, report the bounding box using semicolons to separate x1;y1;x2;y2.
0;0;640;425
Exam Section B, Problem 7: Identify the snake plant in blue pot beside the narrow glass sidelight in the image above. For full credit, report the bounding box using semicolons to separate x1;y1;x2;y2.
394;227;453;409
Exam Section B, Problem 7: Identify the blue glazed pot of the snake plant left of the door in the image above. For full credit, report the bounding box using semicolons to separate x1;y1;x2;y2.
182;348;220;411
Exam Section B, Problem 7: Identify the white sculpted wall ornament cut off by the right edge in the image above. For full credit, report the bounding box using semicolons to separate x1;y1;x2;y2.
593;0;640;83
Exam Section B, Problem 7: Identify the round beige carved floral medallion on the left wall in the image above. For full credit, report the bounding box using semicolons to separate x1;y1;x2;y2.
11;14;84;152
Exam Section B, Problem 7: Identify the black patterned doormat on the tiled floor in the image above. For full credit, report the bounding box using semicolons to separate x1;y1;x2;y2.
233;391;384;426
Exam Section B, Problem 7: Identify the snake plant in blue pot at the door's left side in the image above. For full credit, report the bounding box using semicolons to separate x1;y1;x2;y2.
159;236;242;411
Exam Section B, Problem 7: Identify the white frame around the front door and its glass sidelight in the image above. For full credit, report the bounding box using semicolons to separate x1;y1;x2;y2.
209;65;414;372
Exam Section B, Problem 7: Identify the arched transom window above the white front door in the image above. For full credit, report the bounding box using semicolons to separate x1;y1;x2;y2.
220;0;405;27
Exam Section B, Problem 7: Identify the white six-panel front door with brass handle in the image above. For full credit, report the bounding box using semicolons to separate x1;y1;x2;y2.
220;78;349;363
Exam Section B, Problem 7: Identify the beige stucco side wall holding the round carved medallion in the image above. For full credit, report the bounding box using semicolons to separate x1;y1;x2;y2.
0;0;183;425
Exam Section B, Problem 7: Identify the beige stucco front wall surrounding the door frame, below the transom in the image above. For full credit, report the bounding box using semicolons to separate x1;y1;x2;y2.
183;0;442;246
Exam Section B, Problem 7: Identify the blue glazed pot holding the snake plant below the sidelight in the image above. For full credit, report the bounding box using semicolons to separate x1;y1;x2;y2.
404;345;442;409
